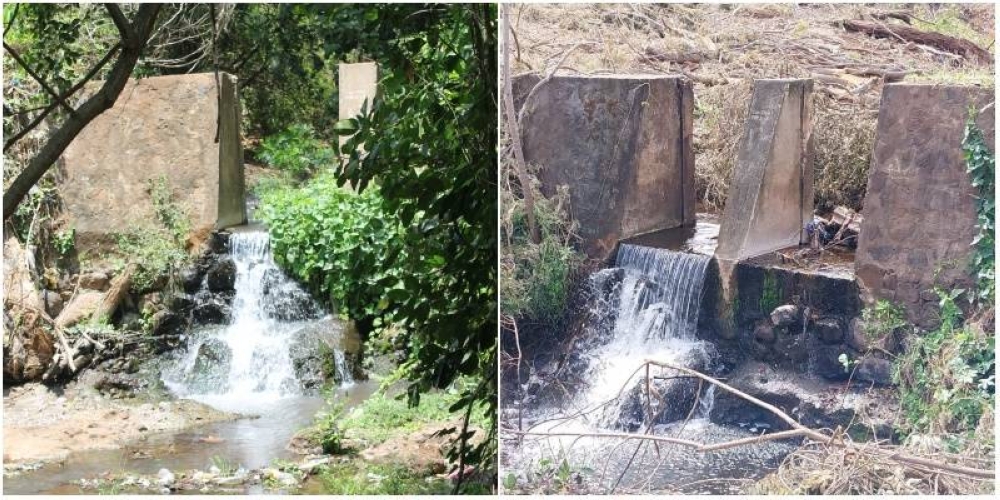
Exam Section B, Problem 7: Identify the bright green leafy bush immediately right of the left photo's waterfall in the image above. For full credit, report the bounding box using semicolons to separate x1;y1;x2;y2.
257;175;408;323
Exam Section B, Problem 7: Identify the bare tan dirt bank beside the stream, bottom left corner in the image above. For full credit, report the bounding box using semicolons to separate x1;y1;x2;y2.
3;384;236;468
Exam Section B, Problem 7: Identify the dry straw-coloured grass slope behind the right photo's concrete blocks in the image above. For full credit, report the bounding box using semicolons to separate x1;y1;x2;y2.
512;4;994;209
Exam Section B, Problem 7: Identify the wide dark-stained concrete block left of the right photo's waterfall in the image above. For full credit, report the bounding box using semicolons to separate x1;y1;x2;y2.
512;75;695;259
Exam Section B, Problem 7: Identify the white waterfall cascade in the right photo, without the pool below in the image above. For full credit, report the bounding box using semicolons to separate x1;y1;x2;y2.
577;244;714;427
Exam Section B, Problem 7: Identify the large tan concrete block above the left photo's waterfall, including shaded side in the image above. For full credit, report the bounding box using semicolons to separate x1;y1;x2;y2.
60;73;246;248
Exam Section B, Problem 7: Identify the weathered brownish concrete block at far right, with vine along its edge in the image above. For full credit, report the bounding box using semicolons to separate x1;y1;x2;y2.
855;84;995;328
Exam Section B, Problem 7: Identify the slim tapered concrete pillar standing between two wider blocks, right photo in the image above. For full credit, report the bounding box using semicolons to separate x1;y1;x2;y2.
715;80;813;261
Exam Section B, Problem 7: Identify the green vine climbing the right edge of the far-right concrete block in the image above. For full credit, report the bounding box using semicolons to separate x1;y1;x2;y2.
962;113;996;305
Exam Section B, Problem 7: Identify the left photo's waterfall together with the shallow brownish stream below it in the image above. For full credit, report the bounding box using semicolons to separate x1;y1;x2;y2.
4;228;377;494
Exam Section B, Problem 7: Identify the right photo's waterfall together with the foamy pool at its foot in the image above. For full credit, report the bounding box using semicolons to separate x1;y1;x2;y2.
502;244;788;493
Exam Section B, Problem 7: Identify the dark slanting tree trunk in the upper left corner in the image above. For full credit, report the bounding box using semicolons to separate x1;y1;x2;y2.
3;4;161;221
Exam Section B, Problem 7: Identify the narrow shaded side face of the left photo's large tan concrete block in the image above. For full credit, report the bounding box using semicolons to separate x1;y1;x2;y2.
216;73;247;228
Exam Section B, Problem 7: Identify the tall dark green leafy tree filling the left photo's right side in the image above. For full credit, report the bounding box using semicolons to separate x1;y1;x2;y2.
333;4;497;480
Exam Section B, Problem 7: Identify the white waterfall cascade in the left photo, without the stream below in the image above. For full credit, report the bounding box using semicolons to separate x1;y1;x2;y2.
162;230;334;409
